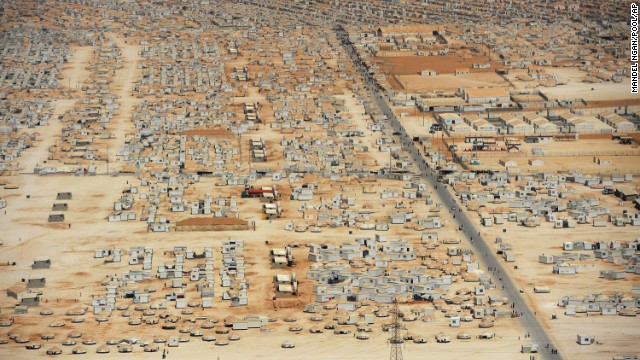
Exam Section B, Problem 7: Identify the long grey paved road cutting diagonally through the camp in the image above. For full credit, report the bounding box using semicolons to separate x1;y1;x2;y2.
336;27;562;360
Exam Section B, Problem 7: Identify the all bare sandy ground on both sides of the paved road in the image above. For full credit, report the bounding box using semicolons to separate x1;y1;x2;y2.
0;4;640;360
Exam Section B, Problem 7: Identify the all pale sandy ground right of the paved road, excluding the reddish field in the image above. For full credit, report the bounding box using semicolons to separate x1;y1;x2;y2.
395;102;640;360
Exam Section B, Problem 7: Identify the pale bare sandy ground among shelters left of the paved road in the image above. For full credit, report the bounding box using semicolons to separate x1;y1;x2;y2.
0;26;528;359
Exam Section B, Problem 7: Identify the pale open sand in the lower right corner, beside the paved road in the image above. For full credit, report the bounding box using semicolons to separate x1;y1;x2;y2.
472;185;640;359
